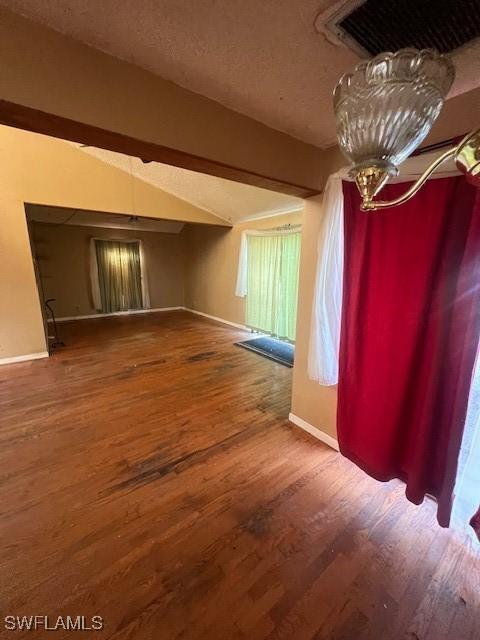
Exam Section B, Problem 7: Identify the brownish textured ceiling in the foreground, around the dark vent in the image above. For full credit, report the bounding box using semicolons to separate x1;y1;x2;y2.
0;0;480;147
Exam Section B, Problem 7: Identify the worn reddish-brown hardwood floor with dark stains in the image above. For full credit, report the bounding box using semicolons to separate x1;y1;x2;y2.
0;312;480;640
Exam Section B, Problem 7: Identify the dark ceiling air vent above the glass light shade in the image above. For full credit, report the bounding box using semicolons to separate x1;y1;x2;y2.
316;0;480;57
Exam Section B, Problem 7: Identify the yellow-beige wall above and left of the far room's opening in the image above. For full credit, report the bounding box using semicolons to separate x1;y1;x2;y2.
0;127;226;360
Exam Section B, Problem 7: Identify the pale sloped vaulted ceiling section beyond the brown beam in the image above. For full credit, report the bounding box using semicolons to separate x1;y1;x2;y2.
75;143;302;224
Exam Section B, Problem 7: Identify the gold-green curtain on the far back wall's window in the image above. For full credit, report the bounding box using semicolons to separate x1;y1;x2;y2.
95;240;143;313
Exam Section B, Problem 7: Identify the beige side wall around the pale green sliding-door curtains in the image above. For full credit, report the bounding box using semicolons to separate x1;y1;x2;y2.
182;212;303;324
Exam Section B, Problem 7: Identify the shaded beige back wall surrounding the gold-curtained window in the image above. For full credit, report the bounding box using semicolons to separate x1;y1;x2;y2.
30;222;183;318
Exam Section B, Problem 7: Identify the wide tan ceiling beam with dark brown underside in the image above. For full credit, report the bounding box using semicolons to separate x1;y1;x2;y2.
0;8;327;197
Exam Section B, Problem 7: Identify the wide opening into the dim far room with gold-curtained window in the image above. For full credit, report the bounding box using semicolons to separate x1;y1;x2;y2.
25;204;188;353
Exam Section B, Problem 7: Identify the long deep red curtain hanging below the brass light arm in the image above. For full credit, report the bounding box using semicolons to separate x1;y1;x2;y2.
337;177;480;526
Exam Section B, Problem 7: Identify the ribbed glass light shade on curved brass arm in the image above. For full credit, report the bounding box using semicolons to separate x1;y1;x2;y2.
333;49;480;211
